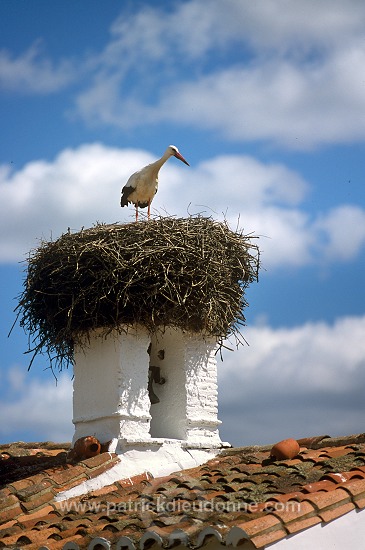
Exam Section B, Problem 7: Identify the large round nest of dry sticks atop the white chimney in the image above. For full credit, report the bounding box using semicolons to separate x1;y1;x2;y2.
17;216;259;369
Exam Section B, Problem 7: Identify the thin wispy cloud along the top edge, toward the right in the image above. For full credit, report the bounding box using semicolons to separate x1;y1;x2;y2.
106;0;365;62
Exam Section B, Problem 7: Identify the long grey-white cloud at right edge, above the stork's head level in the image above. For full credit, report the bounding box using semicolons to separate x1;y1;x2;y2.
156;48;365;149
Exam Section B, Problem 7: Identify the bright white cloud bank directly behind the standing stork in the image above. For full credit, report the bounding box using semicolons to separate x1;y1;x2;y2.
0;144;365;268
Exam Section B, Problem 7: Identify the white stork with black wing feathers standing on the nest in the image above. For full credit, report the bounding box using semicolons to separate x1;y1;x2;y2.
120;149;190;221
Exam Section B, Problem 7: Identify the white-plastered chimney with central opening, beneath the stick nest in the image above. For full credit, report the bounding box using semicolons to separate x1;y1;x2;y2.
73;326;222;460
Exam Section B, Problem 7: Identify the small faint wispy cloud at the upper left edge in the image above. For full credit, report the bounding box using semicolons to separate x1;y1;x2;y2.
0;42;76;94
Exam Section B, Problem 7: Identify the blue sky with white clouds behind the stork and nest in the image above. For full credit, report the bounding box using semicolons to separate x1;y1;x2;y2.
0;0;365;445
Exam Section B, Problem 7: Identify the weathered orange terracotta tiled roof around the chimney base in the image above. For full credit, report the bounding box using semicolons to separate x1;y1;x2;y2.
0;434;365;550
